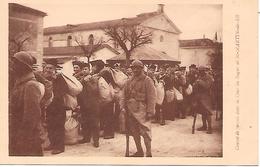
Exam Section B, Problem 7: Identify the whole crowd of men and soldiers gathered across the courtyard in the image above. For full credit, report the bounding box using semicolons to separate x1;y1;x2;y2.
9;52;222;157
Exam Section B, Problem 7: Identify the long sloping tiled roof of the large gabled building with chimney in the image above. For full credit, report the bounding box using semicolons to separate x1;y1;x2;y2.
44;12;161;35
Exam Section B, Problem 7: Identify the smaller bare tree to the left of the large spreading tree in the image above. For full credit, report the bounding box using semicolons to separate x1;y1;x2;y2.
75;36;105;63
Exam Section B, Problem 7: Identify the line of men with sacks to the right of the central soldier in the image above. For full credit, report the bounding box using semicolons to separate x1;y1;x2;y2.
147;64;222;134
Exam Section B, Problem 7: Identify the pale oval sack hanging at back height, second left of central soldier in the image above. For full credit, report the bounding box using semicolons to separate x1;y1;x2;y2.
98;77;115;103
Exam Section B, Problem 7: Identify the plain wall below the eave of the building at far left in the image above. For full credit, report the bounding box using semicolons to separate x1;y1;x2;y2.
9;7;43;65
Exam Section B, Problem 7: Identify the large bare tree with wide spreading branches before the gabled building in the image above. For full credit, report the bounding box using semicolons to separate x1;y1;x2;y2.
103;25;152;67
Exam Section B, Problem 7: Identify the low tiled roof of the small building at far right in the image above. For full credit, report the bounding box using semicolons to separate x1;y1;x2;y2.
179;38;215;47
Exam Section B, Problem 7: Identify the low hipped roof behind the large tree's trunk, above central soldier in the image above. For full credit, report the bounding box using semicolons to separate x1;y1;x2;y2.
107;46;180;63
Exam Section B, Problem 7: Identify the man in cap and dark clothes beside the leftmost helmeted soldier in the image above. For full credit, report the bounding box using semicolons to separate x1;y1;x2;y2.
44;59;67;154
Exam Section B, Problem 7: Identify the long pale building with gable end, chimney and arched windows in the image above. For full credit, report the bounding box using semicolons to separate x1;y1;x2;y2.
44;4;181;64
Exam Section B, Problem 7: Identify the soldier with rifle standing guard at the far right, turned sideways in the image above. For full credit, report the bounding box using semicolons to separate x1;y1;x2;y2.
192;66;213;134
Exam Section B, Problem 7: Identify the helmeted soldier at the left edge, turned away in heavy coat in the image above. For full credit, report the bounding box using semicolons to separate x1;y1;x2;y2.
9;51;44;156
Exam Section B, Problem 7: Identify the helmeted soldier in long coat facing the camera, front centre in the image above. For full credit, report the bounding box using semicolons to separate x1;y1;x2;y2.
121;60;156;157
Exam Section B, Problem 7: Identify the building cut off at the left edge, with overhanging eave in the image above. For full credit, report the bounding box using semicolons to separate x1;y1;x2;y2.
8;3;47;64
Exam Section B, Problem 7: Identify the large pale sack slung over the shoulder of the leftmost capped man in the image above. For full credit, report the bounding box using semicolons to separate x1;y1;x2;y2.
61;74;83;96
